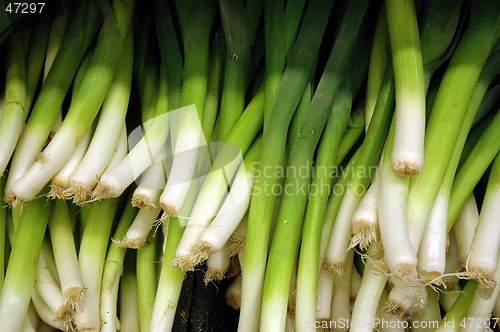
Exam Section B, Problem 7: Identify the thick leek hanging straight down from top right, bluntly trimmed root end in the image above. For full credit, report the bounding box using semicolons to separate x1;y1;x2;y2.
384;0;425;175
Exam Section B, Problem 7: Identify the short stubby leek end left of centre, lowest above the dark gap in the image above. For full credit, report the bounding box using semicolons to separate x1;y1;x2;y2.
118;206;161;249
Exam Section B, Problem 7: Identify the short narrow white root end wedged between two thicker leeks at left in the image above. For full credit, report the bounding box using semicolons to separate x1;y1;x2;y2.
49;128;93;199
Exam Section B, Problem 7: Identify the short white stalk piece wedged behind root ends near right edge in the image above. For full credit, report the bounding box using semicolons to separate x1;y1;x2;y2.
452;194;479;270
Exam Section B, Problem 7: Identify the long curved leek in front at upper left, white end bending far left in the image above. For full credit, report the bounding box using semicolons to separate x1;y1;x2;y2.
12;1;134;204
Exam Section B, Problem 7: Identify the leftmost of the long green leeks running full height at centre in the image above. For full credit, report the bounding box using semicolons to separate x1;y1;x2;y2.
239;1;332;331
